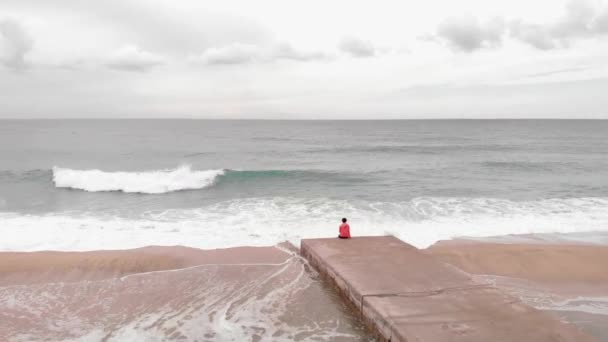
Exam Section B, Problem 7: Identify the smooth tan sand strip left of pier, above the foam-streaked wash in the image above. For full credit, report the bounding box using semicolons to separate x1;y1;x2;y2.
0;246;288;286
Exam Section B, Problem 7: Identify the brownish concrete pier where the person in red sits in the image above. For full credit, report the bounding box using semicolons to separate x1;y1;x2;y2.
301;236;596;342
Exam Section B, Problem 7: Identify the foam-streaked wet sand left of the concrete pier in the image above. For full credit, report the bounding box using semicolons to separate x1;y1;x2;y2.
0;245;369;341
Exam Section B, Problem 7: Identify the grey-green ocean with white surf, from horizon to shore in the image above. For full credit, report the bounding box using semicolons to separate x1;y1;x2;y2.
0;120;608;251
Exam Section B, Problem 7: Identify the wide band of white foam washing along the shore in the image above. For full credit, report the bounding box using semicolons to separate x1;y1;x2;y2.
0;197;608;251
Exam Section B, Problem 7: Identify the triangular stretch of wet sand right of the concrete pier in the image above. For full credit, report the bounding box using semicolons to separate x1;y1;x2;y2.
425;239;608;341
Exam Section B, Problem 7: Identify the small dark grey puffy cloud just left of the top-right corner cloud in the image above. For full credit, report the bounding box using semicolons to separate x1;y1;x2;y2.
437;15;505;52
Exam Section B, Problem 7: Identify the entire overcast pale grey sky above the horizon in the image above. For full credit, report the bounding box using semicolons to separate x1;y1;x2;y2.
0;0;608;119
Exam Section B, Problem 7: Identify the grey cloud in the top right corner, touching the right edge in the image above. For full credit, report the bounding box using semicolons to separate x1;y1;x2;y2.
509;0;608;50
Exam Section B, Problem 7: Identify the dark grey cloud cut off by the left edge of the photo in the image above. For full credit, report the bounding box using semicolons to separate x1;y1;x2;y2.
0;19;33;70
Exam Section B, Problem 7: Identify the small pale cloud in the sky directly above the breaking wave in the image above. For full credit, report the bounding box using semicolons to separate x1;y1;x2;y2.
105;45;165;72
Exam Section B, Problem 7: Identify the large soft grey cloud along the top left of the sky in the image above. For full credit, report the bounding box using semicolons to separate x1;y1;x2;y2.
0;0;271;56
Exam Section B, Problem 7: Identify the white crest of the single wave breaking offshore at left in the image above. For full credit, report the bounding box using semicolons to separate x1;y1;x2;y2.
53;166;224;194
